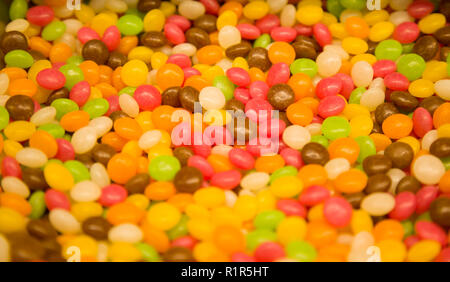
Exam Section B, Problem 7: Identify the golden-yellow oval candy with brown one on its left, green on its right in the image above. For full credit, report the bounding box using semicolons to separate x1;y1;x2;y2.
44;162;74;191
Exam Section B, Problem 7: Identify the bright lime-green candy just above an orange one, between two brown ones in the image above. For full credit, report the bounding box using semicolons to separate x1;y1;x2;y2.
148;156;181;181
